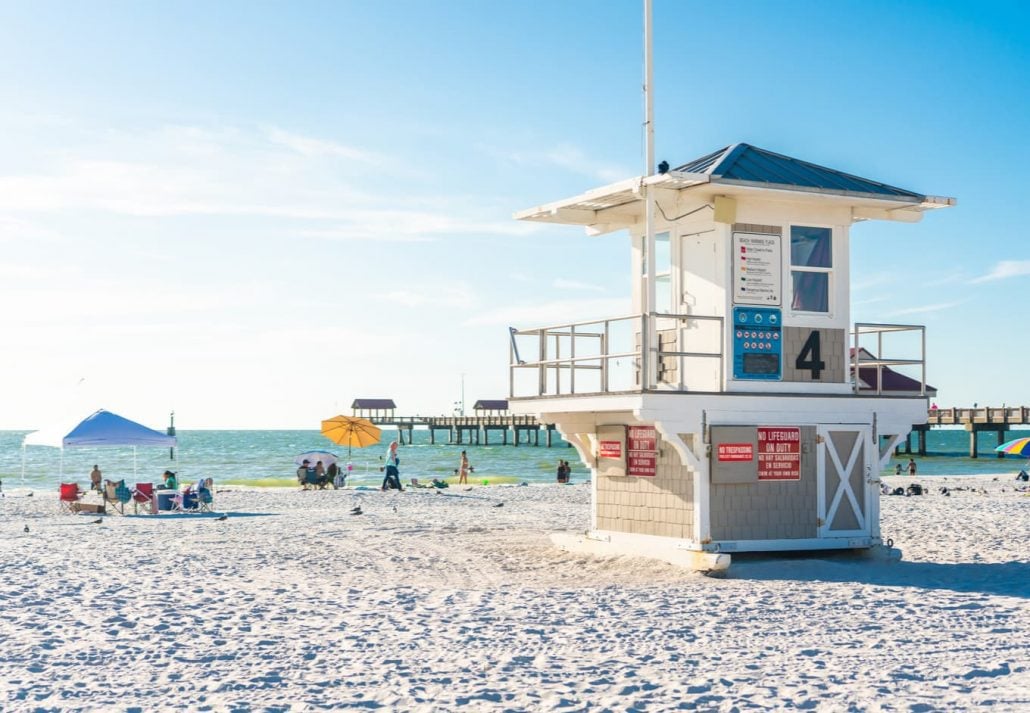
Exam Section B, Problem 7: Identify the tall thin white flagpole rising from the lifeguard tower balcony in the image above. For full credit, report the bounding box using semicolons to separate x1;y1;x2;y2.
641;0;658;388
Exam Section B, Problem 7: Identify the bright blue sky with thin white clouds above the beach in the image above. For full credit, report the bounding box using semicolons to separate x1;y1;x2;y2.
0;0;1030;428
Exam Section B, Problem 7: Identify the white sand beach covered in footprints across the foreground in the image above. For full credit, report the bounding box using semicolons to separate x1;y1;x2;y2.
0;477;1030;711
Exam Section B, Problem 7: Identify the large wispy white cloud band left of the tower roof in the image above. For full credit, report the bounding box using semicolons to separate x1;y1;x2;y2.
0;126;540;241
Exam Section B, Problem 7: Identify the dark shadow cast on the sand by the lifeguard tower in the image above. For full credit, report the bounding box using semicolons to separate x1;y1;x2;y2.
727;552;1030;599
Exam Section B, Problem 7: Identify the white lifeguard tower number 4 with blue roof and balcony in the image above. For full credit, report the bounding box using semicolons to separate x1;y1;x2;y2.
509;143;955;570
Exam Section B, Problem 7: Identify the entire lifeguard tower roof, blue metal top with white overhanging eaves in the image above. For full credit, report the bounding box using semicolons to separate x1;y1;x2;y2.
515;143;956;235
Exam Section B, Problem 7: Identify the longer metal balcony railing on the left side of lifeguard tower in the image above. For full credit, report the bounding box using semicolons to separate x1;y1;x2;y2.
509;313;724;399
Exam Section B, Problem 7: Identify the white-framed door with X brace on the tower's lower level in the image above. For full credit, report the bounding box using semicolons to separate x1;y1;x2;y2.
816;425;877;537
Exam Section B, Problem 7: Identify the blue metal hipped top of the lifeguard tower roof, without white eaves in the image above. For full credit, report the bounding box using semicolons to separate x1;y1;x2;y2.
674;143;926;202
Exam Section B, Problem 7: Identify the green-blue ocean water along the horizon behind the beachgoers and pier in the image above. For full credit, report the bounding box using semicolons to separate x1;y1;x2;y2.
0;422;1030;489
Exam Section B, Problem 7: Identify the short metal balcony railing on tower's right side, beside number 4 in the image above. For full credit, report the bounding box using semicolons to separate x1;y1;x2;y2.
851;322;926;396
